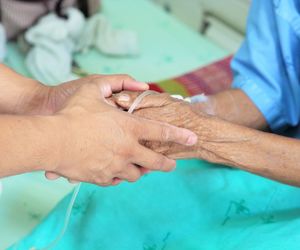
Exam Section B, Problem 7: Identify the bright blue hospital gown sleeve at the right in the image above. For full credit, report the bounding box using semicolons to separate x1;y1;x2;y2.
232;0;300;137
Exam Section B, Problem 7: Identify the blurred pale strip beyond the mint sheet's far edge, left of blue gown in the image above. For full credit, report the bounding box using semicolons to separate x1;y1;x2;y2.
153;0;251;53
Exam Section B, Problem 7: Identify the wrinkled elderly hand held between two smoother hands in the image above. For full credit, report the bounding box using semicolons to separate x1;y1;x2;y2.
113;91;205;159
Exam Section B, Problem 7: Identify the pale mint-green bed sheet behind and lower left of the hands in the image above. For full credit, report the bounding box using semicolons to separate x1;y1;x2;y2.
0;0;229;249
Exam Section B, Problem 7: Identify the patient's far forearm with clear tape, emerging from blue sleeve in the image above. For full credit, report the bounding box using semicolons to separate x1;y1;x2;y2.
193;89;268;130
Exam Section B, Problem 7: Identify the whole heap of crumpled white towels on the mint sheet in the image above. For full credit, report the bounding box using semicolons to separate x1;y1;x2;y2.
25;8;139;85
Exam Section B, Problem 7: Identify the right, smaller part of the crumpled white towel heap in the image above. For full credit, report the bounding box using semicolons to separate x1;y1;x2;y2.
76;13;139;56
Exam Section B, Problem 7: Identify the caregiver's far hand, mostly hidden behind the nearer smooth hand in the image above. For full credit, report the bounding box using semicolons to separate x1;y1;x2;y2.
10;75;149;115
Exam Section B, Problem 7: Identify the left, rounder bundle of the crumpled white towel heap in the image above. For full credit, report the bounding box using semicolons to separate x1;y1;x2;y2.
25;8;85;85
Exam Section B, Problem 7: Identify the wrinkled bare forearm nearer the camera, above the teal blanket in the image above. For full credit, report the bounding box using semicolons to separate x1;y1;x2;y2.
190;115;300;186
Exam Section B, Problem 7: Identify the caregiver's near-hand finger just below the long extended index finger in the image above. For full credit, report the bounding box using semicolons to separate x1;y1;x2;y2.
133;146;176;174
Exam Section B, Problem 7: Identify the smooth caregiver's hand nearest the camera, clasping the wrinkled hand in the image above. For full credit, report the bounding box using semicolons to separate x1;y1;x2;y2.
49;77;197;186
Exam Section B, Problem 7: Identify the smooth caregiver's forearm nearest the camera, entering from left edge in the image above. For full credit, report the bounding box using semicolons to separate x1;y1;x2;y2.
0;115;60;178
